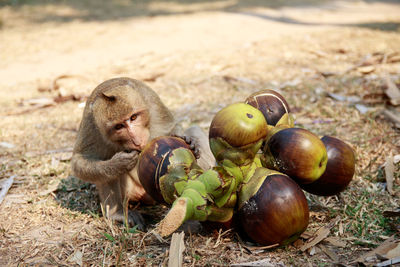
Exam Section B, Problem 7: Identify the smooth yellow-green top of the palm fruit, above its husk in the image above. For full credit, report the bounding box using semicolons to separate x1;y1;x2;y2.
209;103;267;147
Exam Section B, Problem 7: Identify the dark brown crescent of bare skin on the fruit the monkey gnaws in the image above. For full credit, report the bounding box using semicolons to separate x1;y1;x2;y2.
138;136;190;203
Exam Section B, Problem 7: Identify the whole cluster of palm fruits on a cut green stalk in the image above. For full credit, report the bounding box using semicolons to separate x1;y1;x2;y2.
138;90;355;245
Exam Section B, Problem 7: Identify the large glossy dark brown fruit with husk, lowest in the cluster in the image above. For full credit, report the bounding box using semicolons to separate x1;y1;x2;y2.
238;168;309;245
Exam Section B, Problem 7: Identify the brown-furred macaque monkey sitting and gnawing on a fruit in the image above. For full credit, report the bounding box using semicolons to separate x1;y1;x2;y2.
71;78;211;229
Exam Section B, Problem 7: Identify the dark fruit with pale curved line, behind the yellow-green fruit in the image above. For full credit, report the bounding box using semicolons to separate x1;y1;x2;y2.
245;89;290;126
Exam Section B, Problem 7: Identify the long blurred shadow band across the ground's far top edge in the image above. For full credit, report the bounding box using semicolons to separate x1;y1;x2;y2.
0;0;400;31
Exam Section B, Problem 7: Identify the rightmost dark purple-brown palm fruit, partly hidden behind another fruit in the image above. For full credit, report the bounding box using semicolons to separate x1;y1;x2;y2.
301;136;355;196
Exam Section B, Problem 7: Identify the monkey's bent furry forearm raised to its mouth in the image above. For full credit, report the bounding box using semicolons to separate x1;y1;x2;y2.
71;151;138;184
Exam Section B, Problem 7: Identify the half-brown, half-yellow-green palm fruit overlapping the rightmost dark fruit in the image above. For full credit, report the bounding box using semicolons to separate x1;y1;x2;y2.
264;128;328;184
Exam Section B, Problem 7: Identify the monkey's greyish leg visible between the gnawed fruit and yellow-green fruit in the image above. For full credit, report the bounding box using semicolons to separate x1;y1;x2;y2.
184;126;215;170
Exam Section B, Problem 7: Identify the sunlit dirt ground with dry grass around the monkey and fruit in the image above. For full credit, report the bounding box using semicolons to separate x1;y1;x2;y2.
0;0;400;266
